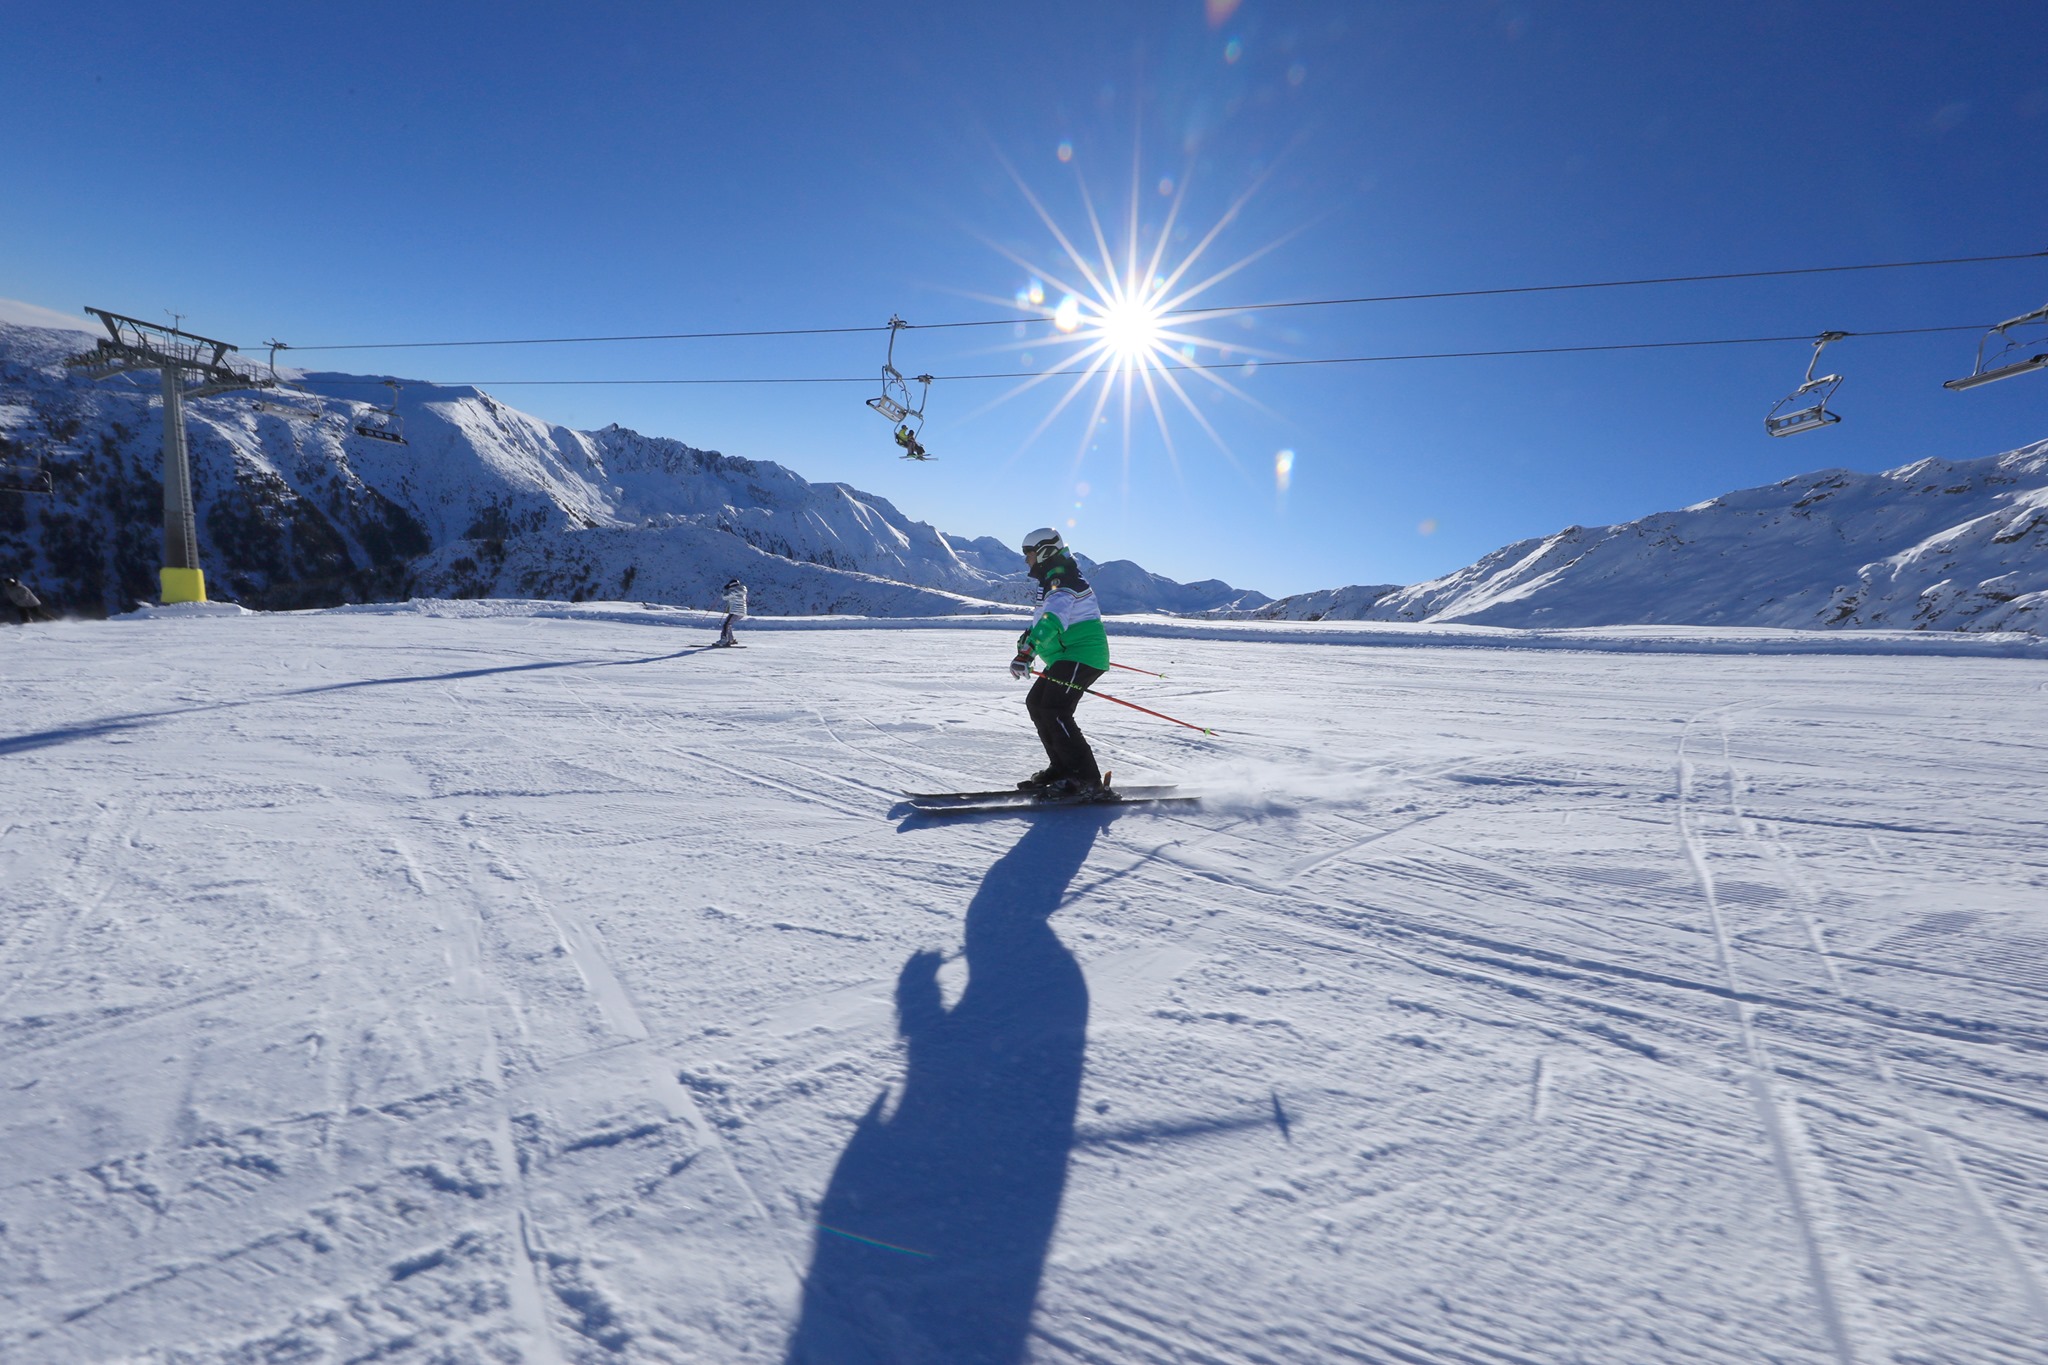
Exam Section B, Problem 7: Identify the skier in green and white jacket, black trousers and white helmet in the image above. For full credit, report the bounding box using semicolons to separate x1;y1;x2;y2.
1010;526;1110;796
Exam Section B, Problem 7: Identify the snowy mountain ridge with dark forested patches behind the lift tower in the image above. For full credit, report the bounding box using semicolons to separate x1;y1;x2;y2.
0;325;1264;616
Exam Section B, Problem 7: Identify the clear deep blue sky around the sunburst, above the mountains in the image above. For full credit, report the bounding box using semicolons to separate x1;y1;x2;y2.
0;0;2048;593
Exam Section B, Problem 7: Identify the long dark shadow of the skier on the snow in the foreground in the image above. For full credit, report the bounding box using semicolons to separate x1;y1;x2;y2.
786;810;1114;1365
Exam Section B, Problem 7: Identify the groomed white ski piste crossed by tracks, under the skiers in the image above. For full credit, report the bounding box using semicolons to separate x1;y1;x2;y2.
0;604;2048;1365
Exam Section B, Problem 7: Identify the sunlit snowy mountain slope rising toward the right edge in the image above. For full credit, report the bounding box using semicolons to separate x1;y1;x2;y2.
1228;442;2048;634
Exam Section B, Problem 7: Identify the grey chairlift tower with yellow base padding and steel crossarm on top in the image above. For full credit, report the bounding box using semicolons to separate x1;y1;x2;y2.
66;307;276;602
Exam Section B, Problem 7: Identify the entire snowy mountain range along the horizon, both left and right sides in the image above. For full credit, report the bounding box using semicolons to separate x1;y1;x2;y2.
0;323;2048;634
